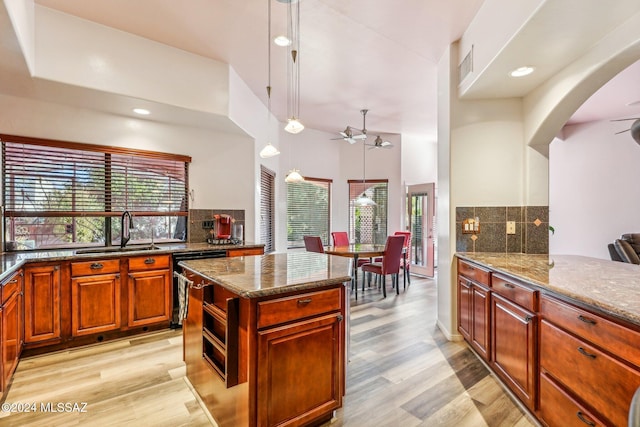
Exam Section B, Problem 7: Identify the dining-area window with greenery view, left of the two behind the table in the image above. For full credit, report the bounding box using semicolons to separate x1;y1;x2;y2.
287;177;331;249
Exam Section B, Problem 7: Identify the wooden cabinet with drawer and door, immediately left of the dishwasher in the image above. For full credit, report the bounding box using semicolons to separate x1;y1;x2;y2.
127;255;173;327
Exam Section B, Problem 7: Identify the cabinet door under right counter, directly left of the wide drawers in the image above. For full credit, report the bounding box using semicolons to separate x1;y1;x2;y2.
491;293;537;410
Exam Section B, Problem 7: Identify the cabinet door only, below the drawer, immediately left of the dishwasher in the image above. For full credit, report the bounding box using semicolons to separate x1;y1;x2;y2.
128;270;172;326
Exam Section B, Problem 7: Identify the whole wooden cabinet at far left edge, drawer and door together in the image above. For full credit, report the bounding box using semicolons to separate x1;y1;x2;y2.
0;271;23;398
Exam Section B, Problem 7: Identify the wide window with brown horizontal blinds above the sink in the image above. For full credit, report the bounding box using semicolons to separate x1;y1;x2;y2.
0;135;191;249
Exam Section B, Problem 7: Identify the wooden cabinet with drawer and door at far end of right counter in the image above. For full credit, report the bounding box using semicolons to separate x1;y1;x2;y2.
458;260;491;361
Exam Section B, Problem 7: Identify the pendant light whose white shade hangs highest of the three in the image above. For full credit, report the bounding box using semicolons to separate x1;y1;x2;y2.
284;1;304;134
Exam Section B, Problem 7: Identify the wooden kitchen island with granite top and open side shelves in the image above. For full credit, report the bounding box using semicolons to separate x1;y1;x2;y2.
180;252;352;427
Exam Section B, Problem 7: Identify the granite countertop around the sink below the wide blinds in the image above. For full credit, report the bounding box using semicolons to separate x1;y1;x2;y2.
0;242;264;280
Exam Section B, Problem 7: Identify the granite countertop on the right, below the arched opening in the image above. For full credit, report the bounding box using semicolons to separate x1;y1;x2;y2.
456;252;640;325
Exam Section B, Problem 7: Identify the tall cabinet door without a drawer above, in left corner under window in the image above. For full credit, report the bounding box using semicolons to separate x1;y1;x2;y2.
24;265;60;343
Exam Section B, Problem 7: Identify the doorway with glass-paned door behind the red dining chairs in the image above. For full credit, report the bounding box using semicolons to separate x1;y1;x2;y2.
407;183;436;277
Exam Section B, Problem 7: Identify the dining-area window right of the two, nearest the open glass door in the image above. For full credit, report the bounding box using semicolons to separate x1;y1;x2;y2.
349;179;388;245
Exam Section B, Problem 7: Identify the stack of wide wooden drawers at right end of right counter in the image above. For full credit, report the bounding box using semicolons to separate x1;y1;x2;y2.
540;297;640;426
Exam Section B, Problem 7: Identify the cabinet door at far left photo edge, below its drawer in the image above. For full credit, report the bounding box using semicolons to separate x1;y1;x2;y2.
0;292;21;387
